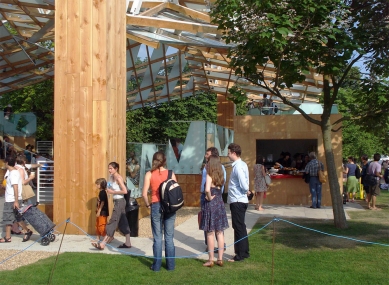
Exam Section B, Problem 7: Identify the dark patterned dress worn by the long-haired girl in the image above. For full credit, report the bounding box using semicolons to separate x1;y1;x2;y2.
200;187;228;232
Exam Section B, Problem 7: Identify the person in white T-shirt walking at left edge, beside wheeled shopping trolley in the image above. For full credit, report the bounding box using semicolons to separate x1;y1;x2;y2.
0;156;32;243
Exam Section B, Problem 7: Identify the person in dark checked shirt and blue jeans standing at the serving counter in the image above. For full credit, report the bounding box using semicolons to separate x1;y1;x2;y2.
304;152;324;209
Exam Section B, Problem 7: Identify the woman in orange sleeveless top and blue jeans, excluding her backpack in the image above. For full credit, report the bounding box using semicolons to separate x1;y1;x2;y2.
142;152;177;271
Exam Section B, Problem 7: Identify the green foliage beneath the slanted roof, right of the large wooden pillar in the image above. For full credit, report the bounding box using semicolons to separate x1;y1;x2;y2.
127;92;217;143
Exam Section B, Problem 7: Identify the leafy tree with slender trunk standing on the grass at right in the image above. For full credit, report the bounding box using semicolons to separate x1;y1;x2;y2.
211;0;389;228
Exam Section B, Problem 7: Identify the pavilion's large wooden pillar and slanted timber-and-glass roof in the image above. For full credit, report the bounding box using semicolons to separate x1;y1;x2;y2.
0;0;322;233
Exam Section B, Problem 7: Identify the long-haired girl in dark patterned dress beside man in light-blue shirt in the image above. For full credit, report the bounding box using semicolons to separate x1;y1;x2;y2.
200;155;228;267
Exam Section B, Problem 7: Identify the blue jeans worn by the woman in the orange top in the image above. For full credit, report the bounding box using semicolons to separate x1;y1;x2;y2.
151;203;176;271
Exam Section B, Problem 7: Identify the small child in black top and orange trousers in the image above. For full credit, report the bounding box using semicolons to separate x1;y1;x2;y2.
95;178;109;240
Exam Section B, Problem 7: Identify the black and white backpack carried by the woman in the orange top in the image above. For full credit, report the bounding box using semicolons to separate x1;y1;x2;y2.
159;170;184;213
